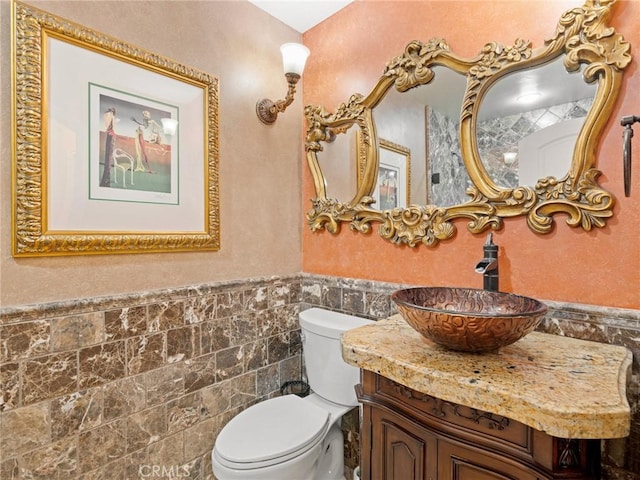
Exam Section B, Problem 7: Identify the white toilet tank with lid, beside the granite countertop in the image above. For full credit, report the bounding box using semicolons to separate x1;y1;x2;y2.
300;308;372;406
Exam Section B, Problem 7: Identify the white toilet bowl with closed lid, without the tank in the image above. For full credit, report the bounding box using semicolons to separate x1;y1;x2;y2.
212;394;353;480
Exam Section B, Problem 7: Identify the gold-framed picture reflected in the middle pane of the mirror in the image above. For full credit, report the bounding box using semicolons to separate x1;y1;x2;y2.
373;139;411;210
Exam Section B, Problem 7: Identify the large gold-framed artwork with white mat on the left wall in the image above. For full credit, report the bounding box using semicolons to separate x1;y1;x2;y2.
12;2;220;257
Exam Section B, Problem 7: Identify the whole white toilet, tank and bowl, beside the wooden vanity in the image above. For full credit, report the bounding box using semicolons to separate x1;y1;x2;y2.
211;308;371;480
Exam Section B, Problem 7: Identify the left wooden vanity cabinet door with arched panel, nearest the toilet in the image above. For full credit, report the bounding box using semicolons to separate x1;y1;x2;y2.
371;409;437;480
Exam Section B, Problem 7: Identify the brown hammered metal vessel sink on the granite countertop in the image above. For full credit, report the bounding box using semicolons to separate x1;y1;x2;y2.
391;287;547;352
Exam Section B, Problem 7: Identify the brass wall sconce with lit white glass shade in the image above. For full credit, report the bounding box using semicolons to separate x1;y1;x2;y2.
256;43;310;125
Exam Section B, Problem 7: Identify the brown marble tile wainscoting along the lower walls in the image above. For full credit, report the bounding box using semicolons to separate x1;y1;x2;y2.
0;274;640;480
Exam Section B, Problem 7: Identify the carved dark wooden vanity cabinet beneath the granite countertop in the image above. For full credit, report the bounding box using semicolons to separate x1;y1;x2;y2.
357;370;600;480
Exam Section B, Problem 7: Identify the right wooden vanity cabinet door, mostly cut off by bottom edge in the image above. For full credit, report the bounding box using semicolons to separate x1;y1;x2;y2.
438;440;546;480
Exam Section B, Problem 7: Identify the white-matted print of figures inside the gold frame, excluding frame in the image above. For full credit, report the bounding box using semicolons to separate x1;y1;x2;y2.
48;37;200;232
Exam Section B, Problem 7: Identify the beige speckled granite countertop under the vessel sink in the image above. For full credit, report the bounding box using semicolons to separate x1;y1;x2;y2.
342;315;632;438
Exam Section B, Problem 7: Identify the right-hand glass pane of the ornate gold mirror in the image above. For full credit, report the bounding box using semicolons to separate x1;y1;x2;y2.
476;56;597;188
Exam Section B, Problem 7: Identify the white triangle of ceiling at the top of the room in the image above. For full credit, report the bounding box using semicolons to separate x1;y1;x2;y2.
249;0;353;33
